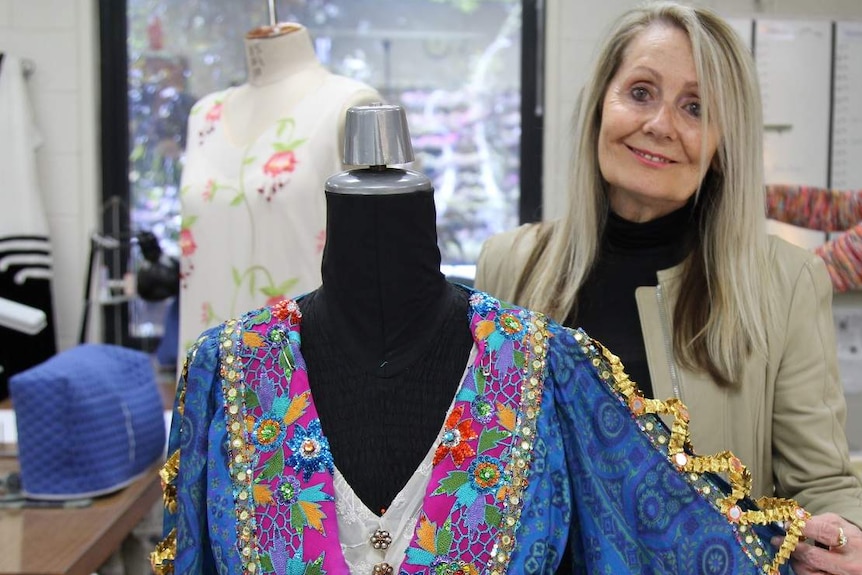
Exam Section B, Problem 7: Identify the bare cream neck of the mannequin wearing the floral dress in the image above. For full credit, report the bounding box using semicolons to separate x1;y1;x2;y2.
245;23;323;86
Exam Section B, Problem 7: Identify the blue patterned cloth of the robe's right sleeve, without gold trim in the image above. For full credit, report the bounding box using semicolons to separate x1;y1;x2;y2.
550;329;785;575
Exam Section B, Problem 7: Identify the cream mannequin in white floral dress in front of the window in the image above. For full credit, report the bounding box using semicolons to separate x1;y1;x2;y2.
179;24;381;357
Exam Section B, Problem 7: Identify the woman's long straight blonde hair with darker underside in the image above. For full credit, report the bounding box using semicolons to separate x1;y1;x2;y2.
515;2;770;386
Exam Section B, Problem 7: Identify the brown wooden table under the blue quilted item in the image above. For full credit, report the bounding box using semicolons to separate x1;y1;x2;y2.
0;457;161;575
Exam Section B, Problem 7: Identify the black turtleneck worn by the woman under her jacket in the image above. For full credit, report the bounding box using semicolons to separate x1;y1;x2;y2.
565;200;696;397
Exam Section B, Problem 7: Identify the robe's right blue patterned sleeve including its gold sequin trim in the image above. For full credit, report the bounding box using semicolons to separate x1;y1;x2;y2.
549;329;800;575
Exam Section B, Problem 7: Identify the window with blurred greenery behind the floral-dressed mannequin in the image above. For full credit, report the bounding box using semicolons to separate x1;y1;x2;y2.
102;0;541;346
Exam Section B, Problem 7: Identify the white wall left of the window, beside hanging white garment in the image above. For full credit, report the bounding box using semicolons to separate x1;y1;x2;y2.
0;0;100;349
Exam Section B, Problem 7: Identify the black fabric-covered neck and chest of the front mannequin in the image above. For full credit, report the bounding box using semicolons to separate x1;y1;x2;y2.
299;191;473;514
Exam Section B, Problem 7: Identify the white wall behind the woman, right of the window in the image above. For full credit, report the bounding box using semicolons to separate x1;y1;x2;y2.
543;0;862;218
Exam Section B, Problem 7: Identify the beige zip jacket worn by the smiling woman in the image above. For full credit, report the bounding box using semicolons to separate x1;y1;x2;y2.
475;224;862;527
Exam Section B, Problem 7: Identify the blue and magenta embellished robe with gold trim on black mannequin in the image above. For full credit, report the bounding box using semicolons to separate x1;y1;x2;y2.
153;292;804;575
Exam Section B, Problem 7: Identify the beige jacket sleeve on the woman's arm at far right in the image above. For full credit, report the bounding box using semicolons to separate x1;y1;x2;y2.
772;250;862;526
